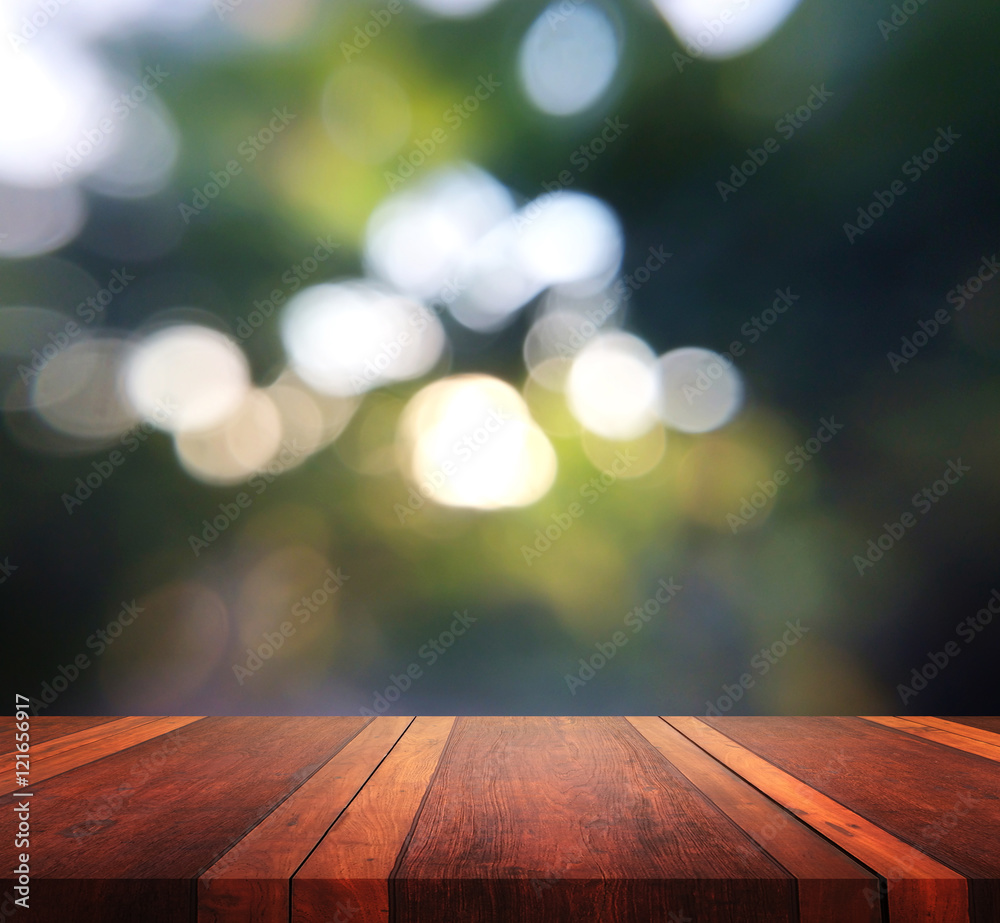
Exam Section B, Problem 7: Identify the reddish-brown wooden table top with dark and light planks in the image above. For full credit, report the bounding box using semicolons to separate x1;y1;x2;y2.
0;717;1000;923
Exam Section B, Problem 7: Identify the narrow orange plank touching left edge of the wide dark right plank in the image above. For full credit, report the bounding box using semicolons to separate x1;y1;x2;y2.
665;718;970;923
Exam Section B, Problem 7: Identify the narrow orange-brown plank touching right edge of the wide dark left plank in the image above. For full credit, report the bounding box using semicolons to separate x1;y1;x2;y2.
198;717;413;923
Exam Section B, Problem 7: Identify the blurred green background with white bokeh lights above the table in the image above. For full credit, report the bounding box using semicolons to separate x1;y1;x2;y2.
0;0;1000;714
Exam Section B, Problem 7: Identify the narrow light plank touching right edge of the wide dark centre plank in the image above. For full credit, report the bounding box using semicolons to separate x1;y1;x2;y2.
627;717;881;923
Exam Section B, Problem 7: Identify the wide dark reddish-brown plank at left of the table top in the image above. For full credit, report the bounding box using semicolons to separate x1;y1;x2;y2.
5;717;368;923
